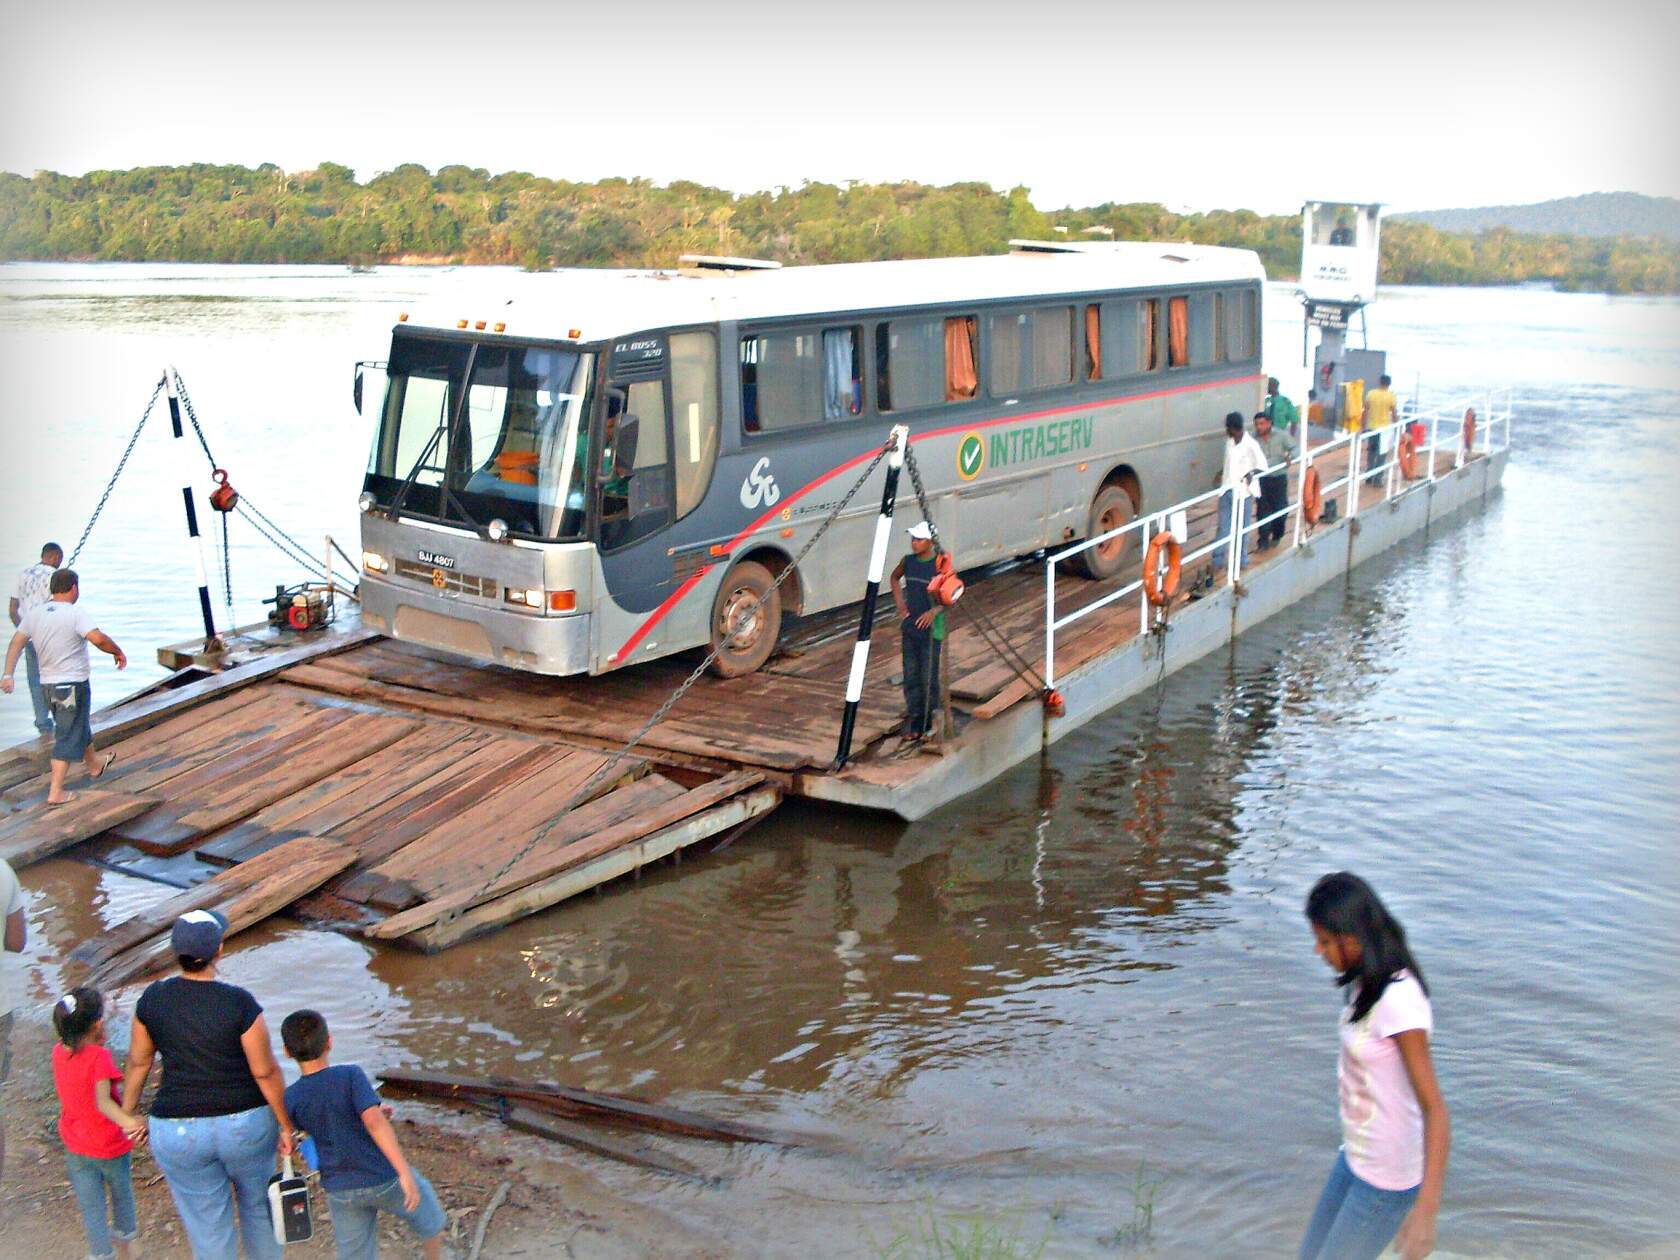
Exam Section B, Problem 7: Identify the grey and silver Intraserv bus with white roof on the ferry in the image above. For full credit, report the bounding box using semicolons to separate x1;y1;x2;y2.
356;242;1265;677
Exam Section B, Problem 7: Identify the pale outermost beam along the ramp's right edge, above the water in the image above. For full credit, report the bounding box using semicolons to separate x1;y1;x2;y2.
398;786;781;953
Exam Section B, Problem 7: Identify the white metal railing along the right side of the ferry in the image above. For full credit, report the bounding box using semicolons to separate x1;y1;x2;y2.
1045;386;1512;687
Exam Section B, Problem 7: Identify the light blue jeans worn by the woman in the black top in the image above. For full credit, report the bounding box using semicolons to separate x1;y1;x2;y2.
146;1107;281;1260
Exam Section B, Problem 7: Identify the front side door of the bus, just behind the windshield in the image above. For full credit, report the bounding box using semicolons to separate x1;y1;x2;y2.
595;343;674;664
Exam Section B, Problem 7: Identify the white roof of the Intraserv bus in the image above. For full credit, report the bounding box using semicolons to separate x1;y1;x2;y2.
396;240;1265;341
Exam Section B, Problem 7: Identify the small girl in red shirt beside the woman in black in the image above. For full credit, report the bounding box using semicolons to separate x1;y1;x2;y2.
52;988;146;1260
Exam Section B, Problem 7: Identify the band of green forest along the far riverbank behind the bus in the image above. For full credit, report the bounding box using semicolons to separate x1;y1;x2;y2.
0;161;1680;294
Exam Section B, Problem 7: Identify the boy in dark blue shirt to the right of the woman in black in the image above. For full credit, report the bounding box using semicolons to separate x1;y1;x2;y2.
281;1011;449;1260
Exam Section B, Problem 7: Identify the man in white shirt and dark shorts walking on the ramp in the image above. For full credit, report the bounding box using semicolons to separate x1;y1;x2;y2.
0;570;128;806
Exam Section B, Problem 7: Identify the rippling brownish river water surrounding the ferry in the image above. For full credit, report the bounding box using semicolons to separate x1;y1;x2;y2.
0;265;1680;1257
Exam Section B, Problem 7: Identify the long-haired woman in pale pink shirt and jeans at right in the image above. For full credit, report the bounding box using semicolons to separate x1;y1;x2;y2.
1300;870;1452;1260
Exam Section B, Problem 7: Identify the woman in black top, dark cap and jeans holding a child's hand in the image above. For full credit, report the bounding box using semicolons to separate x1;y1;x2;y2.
123;911;292;1260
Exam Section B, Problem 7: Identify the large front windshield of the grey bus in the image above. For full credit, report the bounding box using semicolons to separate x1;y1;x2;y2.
366;333;595;539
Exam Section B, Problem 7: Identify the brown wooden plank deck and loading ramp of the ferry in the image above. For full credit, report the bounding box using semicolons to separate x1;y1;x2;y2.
0;450;1482;960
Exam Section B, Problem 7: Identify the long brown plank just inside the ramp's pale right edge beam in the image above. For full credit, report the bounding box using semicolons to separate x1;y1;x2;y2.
368;771;763;941
